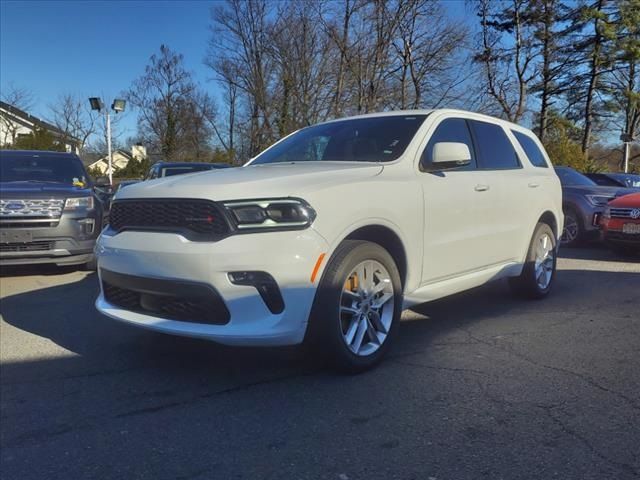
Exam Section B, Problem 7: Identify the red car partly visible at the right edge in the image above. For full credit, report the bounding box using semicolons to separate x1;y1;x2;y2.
600;193;640;254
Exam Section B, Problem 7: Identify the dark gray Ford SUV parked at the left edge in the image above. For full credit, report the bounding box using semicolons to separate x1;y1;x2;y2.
0;150;104;268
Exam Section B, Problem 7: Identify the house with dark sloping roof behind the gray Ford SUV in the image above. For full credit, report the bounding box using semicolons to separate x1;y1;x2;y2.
0;101;80;153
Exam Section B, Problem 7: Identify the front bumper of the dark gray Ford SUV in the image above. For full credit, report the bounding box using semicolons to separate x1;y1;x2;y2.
0;212;100;265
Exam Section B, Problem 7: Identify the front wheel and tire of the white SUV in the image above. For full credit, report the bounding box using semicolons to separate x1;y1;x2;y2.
307;240;402;373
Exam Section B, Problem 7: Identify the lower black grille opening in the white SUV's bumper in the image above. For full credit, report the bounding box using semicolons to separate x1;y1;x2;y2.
100;269;230;325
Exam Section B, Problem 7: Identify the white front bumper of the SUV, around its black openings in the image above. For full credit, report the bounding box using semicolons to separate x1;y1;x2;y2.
96;228;328;346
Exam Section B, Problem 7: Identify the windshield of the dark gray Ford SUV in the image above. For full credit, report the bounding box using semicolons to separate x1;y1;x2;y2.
0;151;87;186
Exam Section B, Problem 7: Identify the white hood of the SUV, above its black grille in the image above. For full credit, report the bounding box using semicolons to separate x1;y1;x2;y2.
116;162;383;200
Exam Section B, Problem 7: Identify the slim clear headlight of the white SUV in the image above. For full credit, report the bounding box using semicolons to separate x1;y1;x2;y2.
224;198;316;230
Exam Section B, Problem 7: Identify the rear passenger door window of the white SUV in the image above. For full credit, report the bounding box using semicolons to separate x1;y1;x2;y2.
469;120;521;170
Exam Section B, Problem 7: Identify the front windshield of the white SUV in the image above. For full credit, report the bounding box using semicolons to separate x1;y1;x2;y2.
251;115;426;165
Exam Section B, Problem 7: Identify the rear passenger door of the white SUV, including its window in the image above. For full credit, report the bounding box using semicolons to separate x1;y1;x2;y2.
469;120;534;264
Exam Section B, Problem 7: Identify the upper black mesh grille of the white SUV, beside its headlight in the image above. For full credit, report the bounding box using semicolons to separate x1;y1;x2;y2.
109;199;230;240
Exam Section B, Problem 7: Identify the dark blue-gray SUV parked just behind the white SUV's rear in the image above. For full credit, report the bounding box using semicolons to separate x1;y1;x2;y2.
556;167;638;246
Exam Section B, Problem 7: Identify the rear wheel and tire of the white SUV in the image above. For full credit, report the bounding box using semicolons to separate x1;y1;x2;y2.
509;223;558;299
